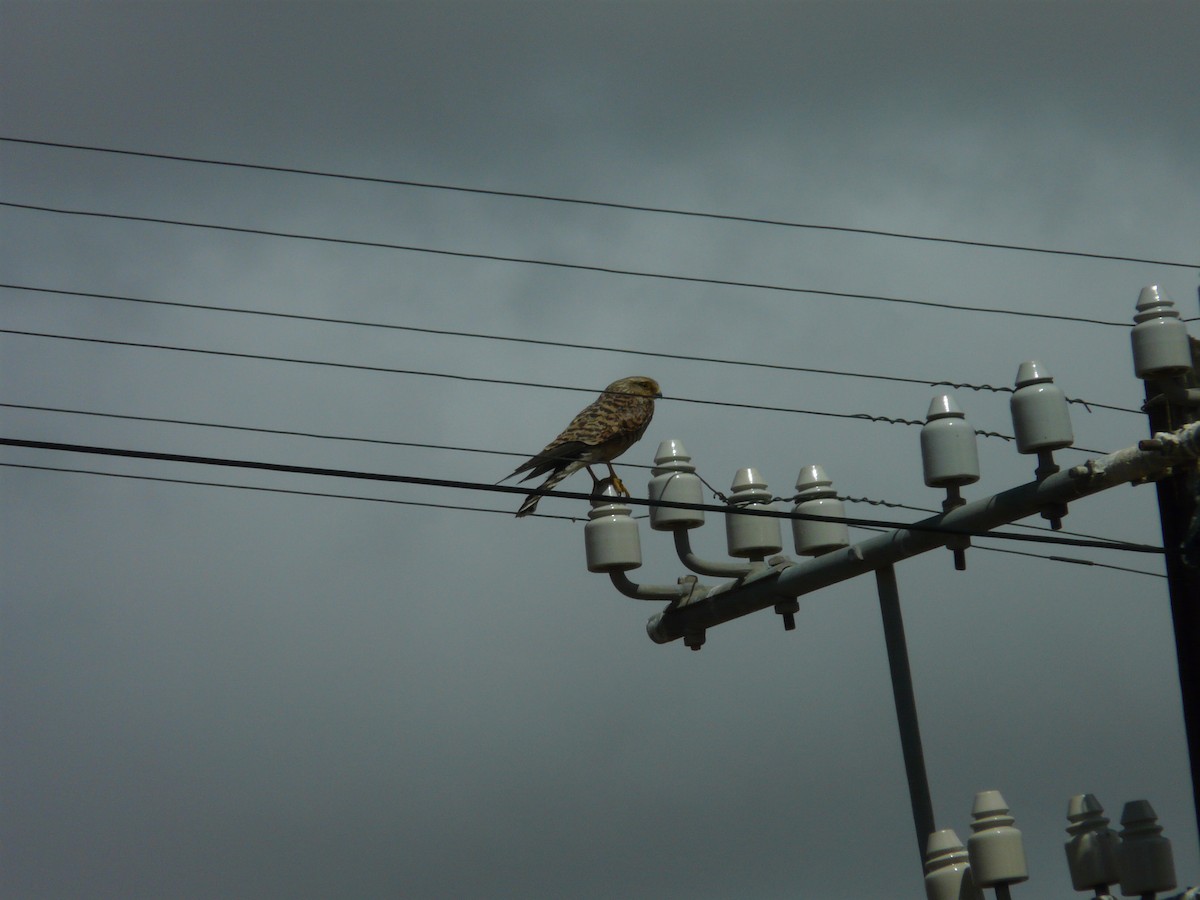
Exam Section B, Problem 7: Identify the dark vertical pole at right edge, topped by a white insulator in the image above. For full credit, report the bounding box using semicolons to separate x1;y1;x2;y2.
1133;284;1200;844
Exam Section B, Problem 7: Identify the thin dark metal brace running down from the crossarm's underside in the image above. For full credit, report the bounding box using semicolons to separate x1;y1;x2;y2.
875;565;937;870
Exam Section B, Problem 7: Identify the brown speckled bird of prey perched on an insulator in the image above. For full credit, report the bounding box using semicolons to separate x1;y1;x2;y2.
502;376;662;516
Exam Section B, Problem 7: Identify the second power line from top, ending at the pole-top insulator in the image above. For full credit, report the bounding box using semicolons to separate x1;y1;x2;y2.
0;200;1128;328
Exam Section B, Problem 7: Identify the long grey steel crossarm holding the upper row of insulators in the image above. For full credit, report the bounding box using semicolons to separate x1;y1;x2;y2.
646;424;1200;643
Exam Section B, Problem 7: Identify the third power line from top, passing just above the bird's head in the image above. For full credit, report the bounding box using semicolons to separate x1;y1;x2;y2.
0;283;1141;415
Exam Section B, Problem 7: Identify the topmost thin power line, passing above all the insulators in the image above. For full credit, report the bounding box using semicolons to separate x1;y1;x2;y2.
0;137;1200;269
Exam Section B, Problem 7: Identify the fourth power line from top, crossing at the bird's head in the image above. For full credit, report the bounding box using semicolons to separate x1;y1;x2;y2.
7;328;1104;454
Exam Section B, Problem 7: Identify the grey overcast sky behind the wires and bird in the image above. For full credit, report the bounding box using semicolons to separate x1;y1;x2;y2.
0;0;1200;900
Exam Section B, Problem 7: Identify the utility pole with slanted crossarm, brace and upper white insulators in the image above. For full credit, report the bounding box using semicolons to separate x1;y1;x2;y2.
584;286;1200;873
